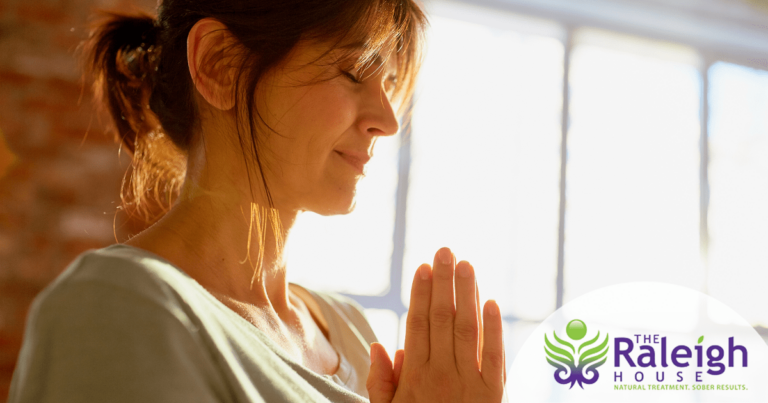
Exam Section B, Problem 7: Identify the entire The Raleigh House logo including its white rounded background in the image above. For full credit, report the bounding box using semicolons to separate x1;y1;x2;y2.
507;282;768;403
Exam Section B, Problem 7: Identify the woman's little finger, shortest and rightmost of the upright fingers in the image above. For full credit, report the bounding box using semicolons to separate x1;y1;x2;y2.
481;300;504;390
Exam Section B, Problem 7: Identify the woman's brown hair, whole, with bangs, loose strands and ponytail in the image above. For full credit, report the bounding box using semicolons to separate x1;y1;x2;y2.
84;0;427;227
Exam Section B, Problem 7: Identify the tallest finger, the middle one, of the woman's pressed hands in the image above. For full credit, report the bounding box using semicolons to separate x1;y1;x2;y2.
426;248;456;368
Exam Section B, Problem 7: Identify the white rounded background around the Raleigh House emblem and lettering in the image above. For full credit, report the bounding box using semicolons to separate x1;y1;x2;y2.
507;282;768;402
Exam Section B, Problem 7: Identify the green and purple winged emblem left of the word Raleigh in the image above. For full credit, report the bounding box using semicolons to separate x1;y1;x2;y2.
544;319;608;389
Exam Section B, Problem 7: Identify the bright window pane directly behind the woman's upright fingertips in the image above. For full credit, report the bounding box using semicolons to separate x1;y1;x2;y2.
403;13;563;319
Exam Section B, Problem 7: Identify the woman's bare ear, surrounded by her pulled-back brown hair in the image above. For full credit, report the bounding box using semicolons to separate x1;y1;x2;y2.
187;18;235;111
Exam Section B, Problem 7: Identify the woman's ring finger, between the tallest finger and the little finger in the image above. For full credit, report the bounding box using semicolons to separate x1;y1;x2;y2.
453;260;480;375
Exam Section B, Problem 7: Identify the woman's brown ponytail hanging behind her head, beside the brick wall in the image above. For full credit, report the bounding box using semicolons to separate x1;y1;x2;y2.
83;12;186;223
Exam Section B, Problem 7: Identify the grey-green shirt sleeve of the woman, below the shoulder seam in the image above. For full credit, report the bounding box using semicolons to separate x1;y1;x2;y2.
9;281;231;403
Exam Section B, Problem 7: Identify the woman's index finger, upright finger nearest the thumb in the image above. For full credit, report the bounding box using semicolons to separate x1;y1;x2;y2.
405;263;432;365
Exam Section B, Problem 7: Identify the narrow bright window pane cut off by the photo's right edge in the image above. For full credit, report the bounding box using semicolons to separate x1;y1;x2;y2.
708;63;768;326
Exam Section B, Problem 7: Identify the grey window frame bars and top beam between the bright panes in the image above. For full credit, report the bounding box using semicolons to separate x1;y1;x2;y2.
344;0;768;345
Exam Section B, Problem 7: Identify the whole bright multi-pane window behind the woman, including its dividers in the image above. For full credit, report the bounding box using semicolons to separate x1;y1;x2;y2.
289;1;768;372
